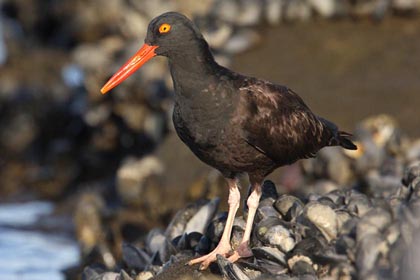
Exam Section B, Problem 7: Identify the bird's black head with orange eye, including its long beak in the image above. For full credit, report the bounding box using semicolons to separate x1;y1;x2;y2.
101;12;205;94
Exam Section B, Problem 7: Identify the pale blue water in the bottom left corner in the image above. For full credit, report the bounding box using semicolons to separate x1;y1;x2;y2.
0;202;80;280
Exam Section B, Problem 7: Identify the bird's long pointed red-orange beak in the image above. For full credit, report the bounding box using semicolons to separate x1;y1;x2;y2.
101;44;158;94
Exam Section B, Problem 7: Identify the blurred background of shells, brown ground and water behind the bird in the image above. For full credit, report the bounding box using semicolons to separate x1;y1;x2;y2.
0;0;420;279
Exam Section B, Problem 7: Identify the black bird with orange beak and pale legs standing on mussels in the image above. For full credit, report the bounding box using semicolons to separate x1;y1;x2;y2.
101;12;357;270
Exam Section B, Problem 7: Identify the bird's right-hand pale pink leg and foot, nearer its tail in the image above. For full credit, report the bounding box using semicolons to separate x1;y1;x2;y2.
229;183;261;262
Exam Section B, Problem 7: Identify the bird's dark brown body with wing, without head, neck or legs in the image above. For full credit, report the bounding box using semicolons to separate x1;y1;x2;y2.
171;62;354;183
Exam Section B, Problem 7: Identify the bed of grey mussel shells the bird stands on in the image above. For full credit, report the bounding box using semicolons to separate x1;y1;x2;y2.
79;115;420;280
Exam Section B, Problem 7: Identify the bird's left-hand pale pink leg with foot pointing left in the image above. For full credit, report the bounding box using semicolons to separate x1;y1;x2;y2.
188;179;241;270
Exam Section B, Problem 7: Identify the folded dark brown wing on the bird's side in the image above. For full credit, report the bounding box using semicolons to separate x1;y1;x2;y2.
235;79;331;164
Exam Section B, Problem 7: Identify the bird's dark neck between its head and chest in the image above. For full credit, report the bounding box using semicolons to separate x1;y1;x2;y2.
168;40;221;95
